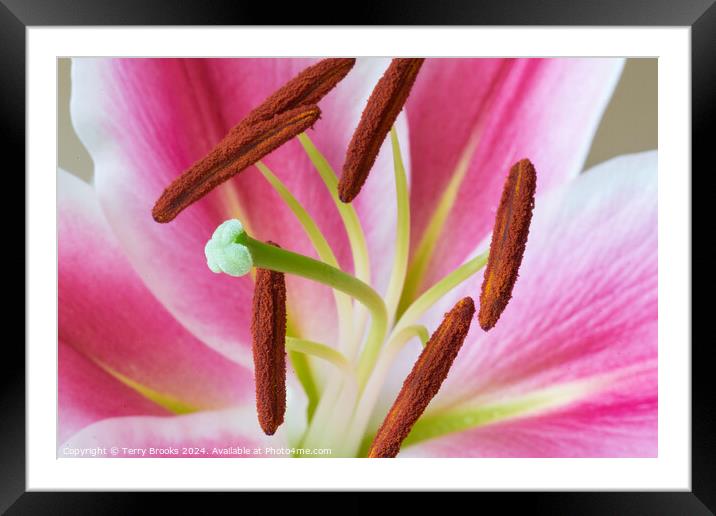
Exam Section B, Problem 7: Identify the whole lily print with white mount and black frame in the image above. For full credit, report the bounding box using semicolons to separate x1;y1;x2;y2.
7;2;716;514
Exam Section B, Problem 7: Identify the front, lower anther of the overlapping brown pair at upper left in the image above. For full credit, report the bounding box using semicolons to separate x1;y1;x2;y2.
152;105;321;222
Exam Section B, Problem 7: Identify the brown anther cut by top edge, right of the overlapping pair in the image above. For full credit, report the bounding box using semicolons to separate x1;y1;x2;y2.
338;59;424;203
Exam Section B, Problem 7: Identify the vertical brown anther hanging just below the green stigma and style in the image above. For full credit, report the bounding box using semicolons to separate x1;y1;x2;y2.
251;242;286;435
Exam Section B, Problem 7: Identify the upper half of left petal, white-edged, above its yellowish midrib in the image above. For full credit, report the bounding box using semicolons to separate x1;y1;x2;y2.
58;171;254;409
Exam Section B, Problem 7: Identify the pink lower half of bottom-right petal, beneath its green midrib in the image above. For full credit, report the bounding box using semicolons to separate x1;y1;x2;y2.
400;366;658;457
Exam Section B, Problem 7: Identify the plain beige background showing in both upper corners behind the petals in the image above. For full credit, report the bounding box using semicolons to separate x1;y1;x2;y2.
58;59;657;180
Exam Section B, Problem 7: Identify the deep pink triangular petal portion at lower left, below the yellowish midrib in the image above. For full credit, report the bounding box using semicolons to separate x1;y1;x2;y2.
57;341;169;443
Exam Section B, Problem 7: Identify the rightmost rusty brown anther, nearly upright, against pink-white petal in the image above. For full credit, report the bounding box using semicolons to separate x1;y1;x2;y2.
478;159;537;331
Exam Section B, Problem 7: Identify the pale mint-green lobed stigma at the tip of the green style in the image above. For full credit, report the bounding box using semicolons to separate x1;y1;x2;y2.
204;219;253;276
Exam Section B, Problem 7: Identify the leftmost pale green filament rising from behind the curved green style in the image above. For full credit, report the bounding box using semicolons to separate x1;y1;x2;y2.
256;161;353;342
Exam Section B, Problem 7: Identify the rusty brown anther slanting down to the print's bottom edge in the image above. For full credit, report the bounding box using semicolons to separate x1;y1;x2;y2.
368;297;475;458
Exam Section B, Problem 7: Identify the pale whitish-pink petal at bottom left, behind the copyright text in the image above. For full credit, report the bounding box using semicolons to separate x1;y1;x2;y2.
59;409;276;458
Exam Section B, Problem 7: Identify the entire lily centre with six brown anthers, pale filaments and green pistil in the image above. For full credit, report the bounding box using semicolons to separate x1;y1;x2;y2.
153;59;536;457
